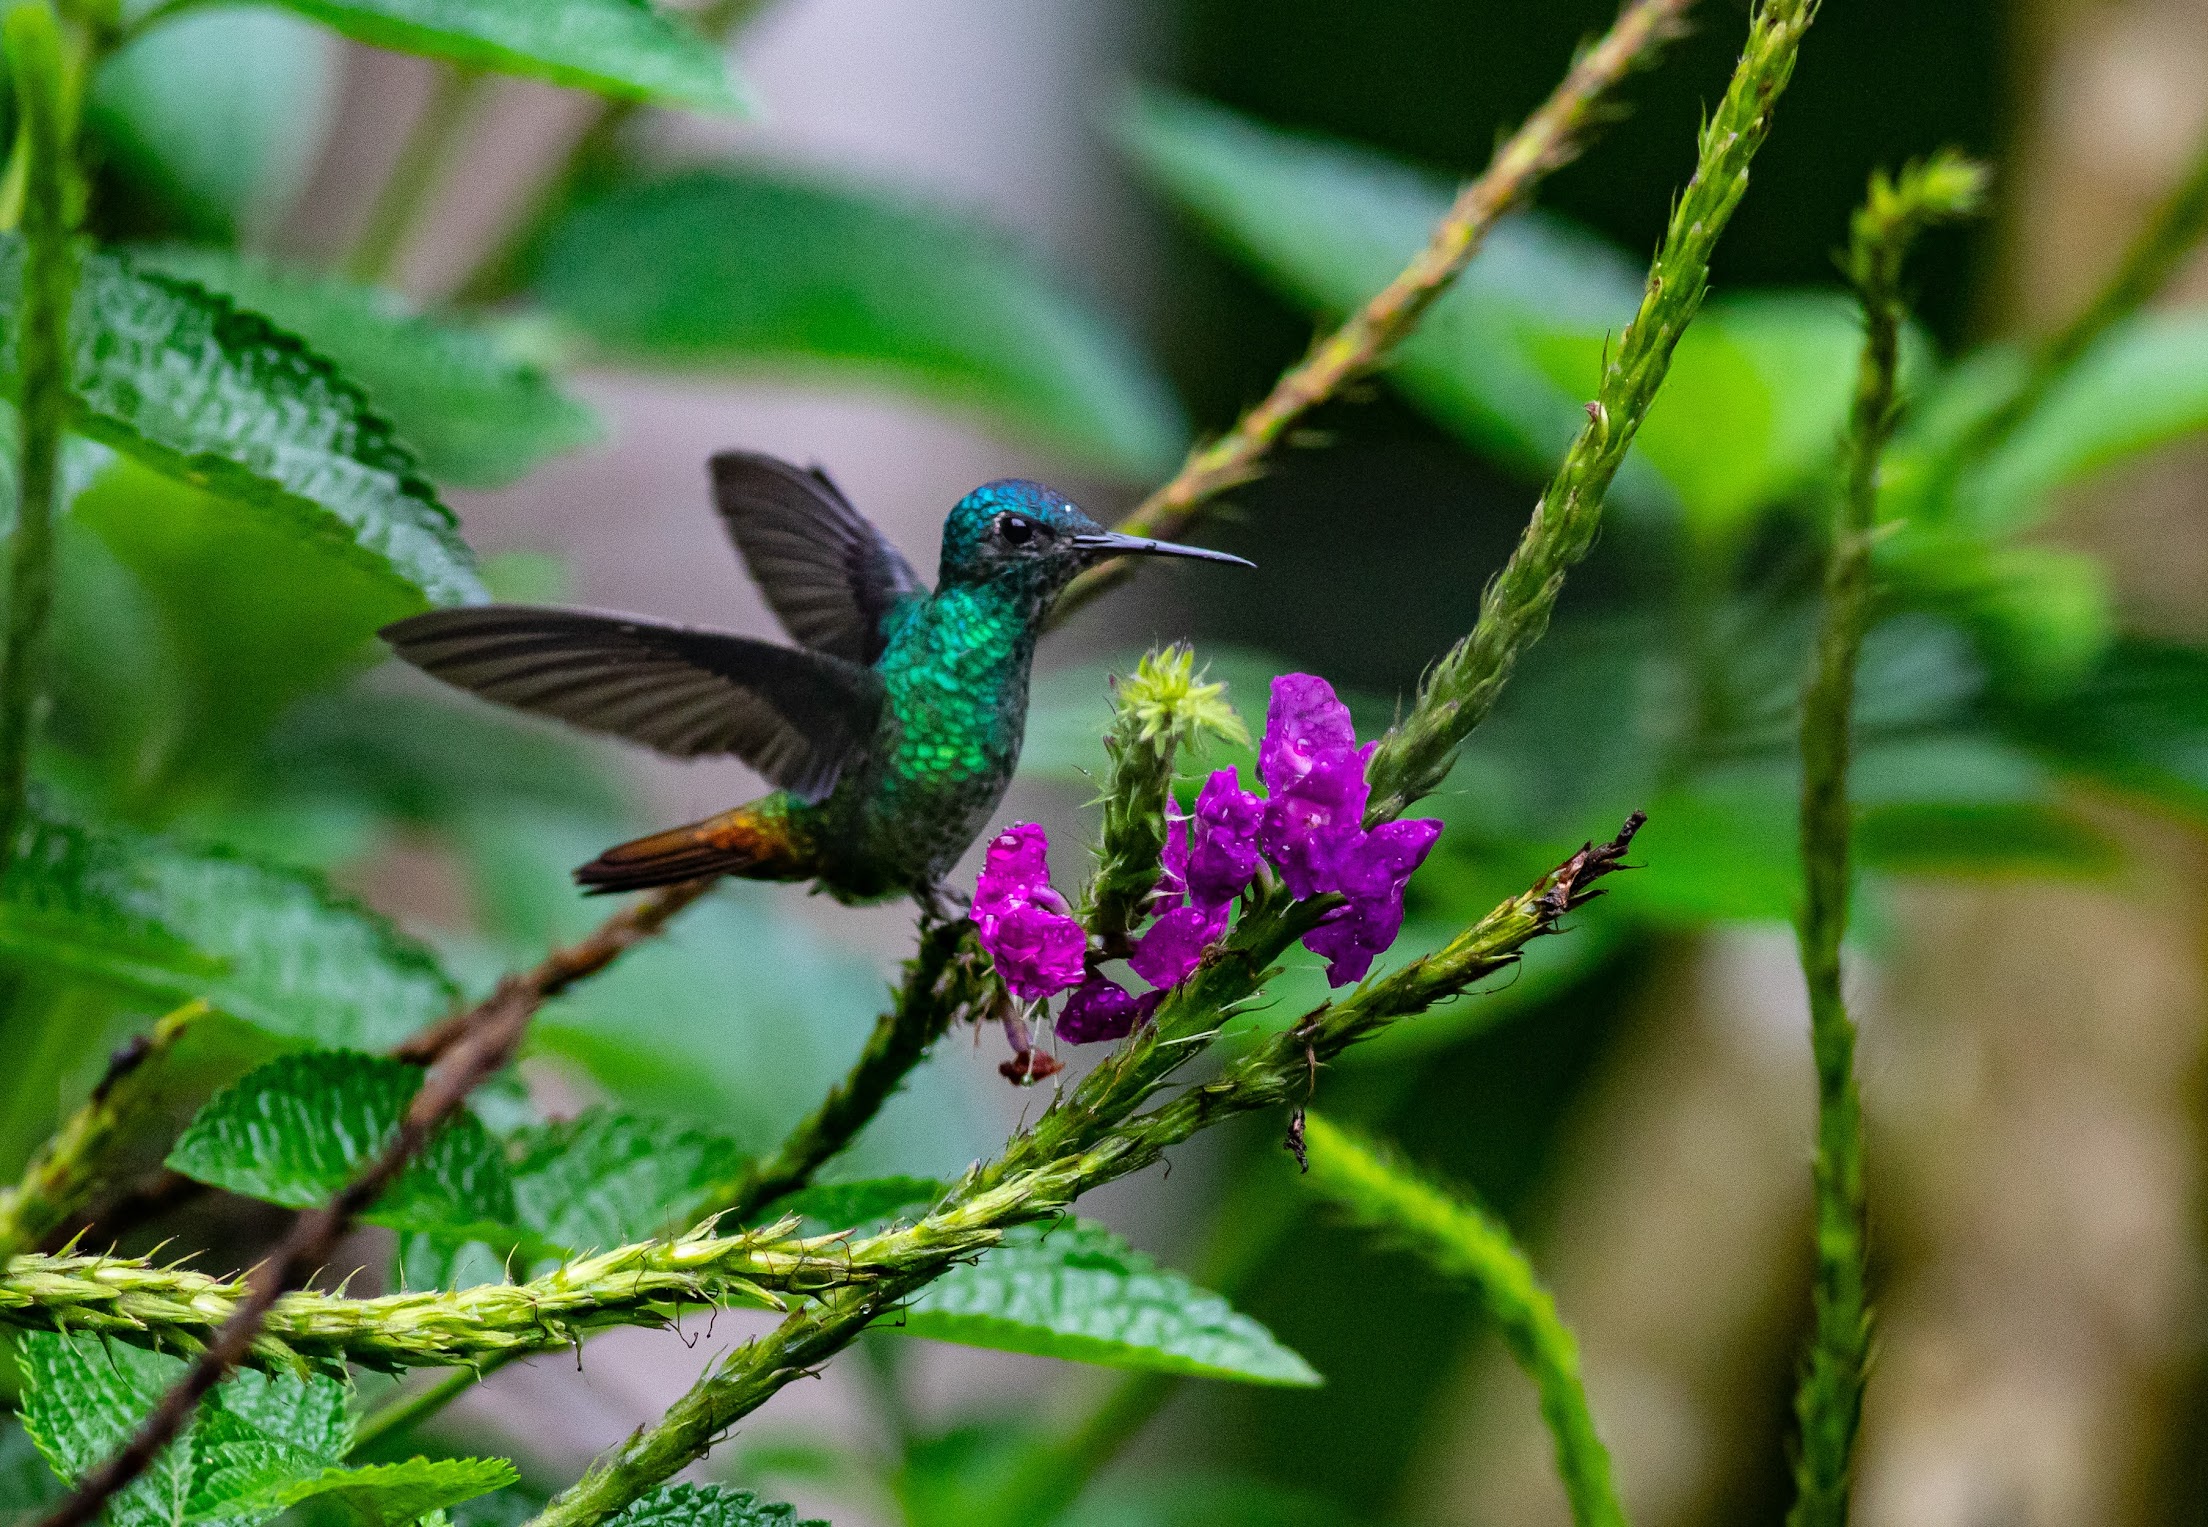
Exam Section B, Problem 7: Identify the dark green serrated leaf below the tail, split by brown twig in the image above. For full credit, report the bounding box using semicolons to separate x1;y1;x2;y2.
168;1050;514;1234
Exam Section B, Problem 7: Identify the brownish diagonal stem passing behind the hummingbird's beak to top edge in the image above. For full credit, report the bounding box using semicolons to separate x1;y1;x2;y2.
1051;0;1694;624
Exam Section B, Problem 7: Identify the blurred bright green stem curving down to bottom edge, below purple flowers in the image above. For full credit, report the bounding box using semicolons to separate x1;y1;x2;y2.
1303;1114;1625;1527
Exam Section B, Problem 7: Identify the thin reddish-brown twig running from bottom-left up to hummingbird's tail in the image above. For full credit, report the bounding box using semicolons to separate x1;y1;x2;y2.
40;880;713;1527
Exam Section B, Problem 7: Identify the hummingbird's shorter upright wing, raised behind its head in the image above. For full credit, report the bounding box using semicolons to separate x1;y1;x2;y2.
711;450;925;666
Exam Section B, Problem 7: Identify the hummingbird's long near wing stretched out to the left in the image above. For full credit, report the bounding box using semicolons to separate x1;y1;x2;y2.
382;605;883;801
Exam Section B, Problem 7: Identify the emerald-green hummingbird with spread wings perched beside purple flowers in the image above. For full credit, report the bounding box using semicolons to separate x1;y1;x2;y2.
382;450;1252;911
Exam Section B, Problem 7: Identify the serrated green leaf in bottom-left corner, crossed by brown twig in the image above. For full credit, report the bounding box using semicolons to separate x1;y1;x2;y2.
15;1331;194;1527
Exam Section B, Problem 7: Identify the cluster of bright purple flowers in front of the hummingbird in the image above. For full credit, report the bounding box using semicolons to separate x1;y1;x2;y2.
974;673;1442;1044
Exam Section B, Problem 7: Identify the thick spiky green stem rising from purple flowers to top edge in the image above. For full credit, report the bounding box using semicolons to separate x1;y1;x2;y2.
1367;0;1817;821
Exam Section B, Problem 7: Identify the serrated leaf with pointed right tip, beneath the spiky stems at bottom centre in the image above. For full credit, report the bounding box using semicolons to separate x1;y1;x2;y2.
888;1220;1320;1386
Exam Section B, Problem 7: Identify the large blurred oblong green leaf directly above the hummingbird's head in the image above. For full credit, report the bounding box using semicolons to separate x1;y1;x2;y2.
537;165;1183;472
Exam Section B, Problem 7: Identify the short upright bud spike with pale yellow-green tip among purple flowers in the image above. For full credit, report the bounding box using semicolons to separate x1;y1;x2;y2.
1082;642;1250;953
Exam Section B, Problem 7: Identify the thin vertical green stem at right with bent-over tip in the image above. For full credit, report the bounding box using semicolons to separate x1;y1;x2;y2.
1786;154;1985;1527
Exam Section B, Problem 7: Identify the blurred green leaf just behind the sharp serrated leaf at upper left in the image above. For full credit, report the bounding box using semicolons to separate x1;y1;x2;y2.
130;247;605;488
